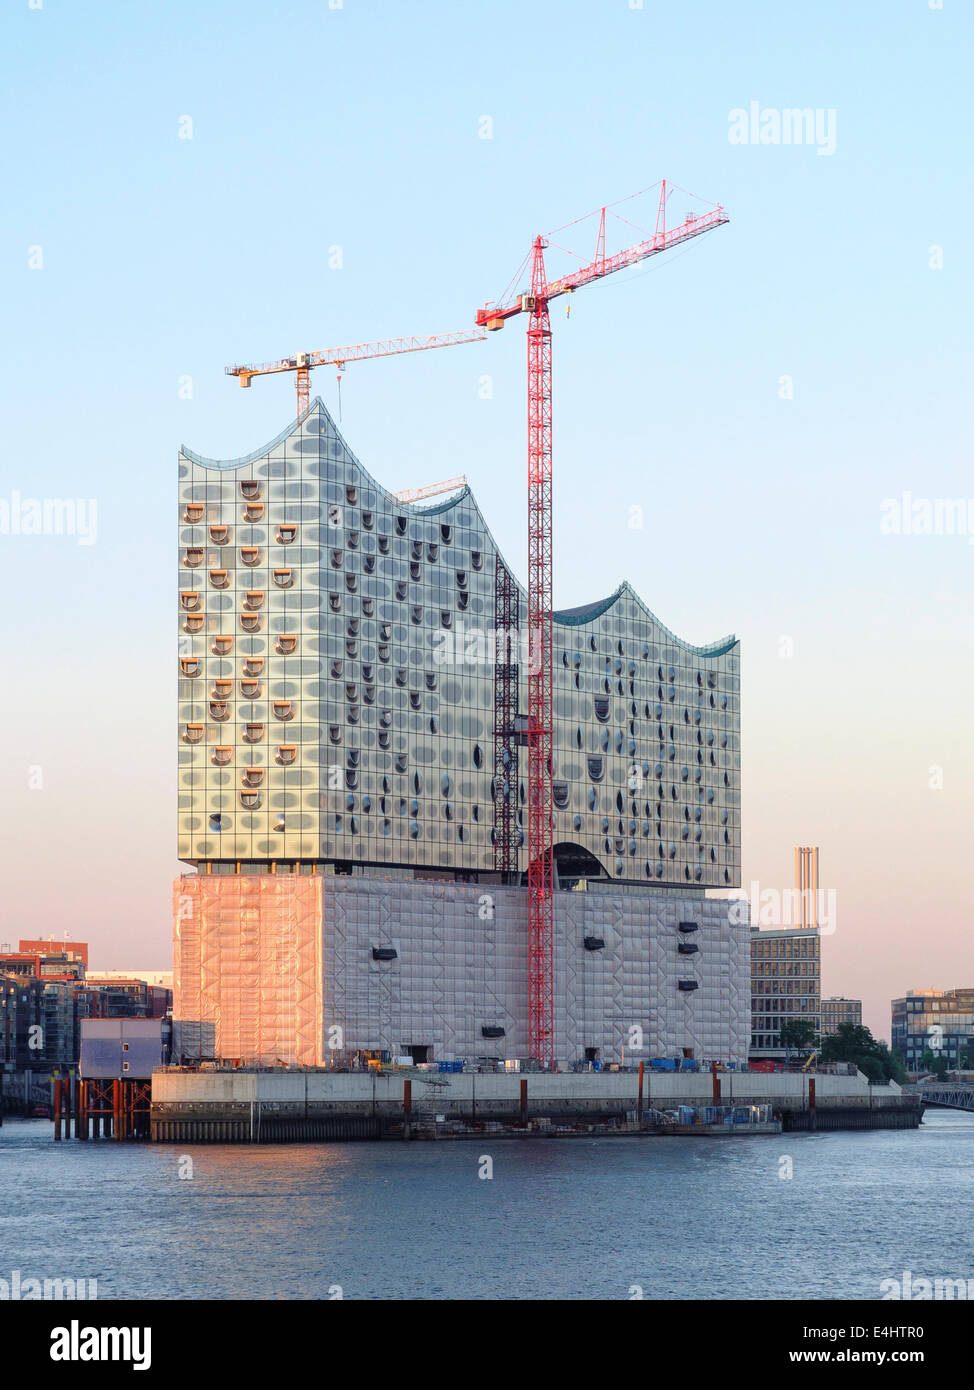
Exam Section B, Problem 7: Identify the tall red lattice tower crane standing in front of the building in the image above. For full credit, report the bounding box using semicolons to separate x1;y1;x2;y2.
477;179;729;1066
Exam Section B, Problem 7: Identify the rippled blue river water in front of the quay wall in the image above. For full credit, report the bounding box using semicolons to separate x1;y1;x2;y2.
0;1111;974;1300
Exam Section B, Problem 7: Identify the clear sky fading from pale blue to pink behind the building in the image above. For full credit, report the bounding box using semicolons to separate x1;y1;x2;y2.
0;0;974;1037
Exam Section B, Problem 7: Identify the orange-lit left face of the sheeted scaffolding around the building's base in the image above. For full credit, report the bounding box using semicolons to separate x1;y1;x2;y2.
172;874;324;1066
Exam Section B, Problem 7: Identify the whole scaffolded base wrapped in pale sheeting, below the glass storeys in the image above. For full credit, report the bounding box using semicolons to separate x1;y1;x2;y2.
174;874;750;1066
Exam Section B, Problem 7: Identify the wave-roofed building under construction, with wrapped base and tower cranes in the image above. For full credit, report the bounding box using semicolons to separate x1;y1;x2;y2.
174;182;750;1070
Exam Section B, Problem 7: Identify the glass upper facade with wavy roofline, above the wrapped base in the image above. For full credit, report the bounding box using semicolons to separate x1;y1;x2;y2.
176;400;741;888
